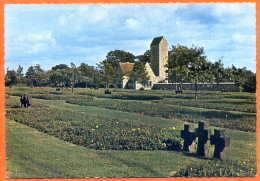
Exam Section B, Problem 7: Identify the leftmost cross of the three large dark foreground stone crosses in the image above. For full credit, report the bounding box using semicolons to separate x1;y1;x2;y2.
181;124;196;152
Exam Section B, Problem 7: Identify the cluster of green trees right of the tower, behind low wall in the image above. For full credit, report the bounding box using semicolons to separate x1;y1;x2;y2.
167;45;256;97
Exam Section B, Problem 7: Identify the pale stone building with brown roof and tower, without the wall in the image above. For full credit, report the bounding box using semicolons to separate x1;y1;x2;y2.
119;36;168;89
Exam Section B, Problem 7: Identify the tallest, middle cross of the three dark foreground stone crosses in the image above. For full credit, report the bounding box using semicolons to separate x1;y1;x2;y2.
195;121;211;157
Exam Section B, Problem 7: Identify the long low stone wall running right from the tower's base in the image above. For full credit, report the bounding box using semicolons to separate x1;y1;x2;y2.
153;83;239;92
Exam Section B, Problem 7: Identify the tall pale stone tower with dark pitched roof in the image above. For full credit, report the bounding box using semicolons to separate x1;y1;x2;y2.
150;36;168;81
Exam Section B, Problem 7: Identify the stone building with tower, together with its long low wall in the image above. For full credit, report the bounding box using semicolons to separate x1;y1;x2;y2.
118;36;239;92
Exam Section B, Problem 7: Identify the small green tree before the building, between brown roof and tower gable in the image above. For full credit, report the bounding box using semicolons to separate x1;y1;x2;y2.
130;62;150;86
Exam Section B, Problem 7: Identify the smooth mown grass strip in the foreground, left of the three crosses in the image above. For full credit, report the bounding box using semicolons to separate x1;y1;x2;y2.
6;119;210;178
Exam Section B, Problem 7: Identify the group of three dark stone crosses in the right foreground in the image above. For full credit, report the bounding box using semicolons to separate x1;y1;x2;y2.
181;121;230;159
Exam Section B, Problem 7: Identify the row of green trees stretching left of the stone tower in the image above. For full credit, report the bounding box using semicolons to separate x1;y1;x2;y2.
5;50;149;91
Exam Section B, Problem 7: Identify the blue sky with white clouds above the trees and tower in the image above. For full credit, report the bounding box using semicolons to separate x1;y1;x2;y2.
5;3;256;73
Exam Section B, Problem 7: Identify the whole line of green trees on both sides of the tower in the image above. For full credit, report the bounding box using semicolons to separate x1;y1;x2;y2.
5;45;256;92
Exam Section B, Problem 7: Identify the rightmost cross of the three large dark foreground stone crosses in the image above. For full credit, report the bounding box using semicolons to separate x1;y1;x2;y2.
210;129;230;159
